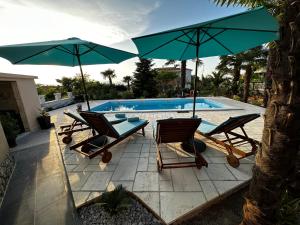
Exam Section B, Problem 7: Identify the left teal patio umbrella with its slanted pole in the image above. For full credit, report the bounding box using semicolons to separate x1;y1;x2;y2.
0;38;136;110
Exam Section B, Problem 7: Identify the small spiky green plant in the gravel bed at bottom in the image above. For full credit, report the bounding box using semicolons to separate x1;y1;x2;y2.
98;185;132;215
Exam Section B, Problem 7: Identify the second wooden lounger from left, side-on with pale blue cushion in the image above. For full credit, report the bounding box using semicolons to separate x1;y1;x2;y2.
70;112;148;163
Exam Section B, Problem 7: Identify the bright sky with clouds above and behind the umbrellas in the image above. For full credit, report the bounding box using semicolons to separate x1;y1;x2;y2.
0;0;245;85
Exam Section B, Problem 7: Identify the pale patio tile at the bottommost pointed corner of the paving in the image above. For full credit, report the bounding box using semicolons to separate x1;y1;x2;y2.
160;192;206;223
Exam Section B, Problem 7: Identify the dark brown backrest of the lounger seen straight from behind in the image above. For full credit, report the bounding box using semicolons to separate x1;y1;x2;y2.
156;118;201;143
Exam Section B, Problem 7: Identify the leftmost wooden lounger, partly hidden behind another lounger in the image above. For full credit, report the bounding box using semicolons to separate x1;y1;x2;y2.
58;111;127;144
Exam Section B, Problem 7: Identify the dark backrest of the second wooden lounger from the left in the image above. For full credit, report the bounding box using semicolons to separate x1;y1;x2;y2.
80;112;120;138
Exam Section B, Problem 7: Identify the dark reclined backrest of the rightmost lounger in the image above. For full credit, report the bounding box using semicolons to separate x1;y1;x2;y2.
208;114;260;135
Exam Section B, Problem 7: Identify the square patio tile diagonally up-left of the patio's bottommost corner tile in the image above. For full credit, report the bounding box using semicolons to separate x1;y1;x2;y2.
133;172;159;191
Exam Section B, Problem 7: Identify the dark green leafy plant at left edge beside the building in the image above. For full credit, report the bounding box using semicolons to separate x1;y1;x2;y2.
0;115;20;148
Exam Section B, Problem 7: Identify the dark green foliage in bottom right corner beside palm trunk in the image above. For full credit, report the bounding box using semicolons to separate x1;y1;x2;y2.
278;191;300;225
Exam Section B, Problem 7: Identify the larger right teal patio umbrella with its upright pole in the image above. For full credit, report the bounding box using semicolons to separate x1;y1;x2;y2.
132;7;279;116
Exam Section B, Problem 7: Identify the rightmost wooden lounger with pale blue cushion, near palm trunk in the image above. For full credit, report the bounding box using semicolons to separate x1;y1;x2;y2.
197;114;260;168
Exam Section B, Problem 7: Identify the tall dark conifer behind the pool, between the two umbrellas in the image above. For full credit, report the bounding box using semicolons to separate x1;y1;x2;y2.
132;58;158;98
